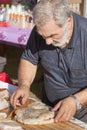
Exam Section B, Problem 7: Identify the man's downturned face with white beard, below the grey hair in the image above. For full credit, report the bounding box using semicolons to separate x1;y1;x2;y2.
37;20;70;47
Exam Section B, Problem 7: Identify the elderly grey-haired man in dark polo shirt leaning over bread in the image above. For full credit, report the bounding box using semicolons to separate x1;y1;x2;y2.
11;0;87;122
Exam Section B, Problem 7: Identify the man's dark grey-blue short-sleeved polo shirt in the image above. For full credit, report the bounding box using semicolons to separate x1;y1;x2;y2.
22;13;87;103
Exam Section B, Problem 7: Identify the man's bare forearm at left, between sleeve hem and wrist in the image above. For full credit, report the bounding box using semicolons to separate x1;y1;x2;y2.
18;59;37;87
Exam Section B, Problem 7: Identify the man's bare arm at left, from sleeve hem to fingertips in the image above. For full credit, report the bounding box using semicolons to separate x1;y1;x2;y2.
11;59;37;108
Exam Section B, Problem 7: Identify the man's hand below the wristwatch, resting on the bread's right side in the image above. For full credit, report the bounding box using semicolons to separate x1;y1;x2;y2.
52;97;77;123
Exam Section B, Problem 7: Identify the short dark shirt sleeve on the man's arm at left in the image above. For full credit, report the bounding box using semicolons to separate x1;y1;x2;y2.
21;27;40;65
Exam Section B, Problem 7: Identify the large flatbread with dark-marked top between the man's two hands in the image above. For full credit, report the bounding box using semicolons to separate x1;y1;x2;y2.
15;102;54;125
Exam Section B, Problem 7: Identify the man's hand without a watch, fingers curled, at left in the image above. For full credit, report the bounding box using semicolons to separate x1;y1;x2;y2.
10;87;29;109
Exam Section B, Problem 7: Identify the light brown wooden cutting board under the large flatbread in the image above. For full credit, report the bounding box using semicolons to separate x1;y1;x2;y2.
23;122;85;130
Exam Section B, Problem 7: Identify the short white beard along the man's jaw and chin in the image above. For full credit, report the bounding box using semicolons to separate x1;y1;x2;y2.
52;24;71;47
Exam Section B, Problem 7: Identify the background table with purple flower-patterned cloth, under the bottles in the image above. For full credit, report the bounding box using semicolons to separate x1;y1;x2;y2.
0;26;32;47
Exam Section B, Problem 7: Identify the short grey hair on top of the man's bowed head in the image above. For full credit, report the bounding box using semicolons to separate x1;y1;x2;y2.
33;0;72;27
